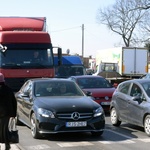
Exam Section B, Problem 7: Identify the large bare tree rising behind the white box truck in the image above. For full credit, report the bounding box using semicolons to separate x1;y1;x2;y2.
97;0;145;47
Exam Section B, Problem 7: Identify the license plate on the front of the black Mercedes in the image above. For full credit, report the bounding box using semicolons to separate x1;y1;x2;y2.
66;121;87;127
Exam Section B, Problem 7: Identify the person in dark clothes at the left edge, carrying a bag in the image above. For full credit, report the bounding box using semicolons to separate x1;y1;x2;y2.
0;73;17;150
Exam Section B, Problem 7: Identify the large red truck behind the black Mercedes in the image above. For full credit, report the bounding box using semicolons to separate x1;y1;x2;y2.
0;17;61;91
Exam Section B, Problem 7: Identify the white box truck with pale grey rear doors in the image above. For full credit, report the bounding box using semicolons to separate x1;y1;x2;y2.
93;47;148;82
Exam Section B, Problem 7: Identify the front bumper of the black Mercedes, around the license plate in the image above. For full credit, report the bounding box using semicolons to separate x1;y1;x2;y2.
37;115;105;134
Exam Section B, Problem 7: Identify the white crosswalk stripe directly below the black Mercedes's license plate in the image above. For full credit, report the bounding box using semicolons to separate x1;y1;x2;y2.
57;142;93;147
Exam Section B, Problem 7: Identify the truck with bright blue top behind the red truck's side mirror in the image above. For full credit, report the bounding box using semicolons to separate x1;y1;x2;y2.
54;55;86;78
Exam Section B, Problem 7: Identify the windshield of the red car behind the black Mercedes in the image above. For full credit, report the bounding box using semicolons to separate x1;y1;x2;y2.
77;78;112;89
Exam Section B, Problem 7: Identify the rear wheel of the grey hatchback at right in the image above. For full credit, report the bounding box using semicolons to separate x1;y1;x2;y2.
110;108;121;126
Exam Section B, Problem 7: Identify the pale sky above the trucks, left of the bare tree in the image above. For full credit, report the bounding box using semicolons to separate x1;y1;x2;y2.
0;0;121;57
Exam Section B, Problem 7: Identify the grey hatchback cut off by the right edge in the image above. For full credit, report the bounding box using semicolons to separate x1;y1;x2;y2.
110;79;150;136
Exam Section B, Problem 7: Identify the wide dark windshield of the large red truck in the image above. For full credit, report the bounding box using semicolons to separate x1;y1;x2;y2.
0;49;53;69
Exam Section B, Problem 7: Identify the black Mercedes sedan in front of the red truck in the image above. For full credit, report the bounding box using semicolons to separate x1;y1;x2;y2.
15;78;105;138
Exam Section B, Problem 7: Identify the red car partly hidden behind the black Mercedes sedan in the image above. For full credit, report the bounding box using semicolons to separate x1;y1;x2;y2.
69;75;115;112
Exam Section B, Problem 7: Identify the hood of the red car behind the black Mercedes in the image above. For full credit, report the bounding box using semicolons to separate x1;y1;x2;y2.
82;88;115;97
